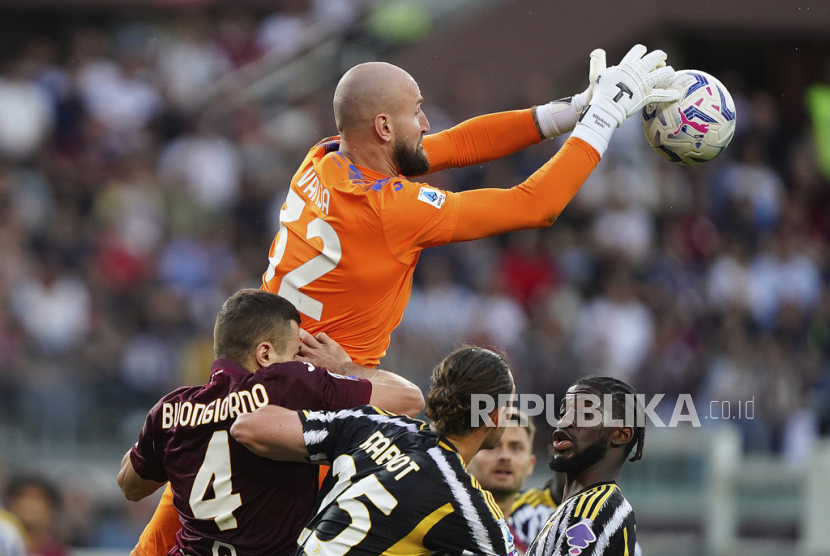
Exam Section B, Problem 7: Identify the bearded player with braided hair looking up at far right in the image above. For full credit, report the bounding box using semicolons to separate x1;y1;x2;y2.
527;377;645;556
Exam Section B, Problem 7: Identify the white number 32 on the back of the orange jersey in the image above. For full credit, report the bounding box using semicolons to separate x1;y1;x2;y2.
265;189;343;320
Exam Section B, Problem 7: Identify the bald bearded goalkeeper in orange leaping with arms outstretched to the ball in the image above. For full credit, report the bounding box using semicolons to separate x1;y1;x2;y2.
137;45;679;556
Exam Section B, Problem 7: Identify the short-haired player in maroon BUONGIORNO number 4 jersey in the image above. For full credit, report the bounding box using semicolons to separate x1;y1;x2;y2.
118;289;423;556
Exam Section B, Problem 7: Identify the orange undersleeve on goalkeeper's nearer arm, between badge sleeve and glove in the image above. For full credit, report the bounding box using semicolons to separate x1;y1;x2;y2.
451;138;600;242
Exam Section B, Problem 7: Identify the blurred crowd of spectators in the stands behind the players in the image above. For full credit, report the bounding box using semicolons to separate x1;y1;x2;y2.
0;0;830;546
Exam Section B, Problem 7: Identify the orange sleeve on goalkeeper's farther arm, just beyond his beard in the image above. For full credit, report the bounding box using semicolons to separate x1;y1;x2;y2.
423;109;542;173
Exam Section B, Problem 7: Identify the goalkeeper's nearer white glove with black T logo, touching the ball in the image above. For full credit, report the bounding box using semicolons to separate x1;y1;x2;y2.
572;44;680;155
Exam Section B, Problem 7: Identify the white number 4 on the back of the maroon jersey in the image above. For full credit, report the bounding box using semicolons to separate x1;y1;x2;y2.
190;431;242;531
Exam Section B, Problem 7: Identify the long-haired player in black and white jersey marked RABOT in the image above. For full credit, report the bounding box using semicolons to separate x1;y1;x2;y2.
231;347;515;556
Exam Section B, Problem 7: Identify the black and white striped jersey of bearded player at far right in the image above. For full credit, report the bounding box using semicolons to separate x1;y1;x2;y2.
526;482;636;556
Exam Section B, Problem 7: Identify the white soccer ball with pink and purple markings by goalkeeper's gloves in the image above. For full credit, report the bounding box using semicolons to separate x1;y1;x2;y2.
643;70;735;166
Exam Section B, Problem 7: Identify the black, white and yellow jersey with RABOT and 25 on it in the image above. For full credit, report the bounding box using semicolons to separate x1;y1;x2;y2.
296;406;515;556
